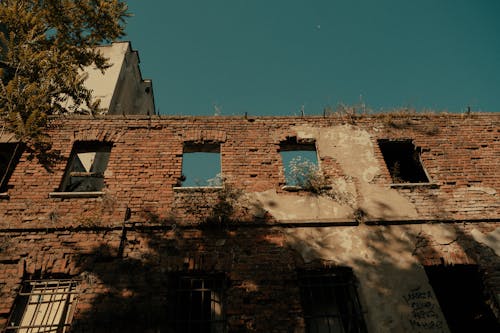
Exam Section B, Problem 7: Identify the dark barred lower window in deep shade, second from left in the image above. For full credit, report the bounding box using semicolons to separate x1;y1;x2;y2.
169;274;227;333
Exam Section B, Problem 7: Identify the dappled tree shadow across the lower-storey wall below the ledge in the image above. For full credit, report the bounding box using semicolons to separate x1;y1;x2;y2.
60;192;500;332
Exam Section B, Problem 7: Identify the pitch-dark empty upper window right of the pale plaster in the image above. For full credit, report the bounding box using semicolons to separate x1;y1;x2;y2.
378;139;429;183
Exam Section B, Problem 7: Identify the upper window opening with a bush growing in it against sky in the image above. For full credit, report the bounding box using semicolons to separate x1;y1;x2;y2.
280;138;320;188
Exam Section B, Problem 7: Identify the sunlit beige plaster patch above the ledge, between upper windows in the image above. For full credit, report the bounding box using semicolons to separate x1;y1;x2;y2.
253;125;418;222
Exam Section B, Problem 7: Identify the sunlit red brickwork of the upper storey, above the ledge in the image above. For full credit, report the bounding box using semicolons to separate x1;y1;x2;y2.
0;114;500;229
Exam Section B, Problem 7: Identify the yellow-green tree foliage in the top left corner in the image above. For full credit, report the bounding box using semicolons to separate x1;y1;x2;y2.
0;0;128;147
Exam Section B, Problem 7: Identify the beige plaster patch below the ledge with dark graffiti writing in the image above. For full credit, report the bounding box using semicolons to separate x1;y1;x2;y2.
284;225;448;332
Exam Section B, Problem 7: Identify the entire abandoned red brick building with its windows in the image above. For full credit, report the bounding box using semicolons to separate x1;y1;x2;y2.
0;113;500;332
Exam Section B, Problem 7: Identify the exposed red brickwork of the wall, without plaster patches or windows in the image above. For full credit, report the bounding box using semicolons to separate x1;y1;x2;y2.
0;114;500;332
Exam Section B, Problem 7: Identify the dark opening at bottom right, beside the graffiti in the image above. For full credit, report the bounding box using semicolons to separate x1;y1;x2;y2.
425;265;500;333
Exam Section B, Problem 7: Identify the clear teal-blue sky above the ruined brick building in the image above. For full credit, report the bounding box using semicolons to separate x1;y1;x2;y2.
124;0;500;115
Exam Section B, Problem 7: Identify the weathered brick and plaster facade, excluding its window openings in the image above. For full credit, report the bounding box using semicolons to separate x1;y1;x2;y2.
0;114;500;332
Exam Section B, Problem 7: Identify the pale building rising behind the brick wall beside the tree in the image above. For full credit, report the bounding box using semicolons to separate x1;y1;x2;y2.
73;41;155;115
